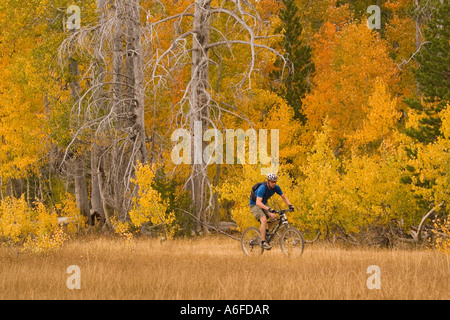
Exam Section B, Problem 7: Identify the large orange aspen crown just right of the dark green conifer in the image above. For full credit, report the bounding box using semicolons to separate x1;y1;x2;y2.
304;22;397;152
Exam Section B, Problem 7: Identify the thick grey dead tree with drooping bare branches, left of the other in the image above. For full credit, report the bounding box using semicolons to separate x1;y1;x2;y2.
59;0;147;222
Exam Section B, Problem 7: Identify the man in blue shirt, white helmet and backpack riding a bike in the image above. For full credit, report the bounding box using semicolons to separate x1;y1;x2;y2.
250;173;294;250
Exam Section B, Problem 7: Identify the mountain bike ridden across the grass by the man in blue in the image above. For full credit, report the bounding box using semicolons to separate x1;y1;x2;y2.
241;210;305;257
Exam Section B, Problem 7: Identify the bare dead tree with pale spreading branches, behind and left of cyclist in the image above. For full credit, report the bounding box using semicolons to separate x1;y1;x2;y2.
146;0;286;232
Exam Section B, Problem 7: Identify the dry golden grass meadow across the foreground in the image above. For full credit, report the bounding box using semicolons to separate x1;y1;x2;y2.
0;237;450;300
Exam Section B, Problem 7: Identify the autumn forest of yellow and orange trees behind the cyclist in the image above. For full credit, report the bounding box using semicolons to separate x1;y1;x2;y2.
0;0;450;253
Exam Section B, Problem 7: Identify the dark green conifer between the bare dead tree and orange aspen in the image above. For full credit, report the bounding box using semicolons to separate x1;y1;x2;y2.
271;0;315;123
